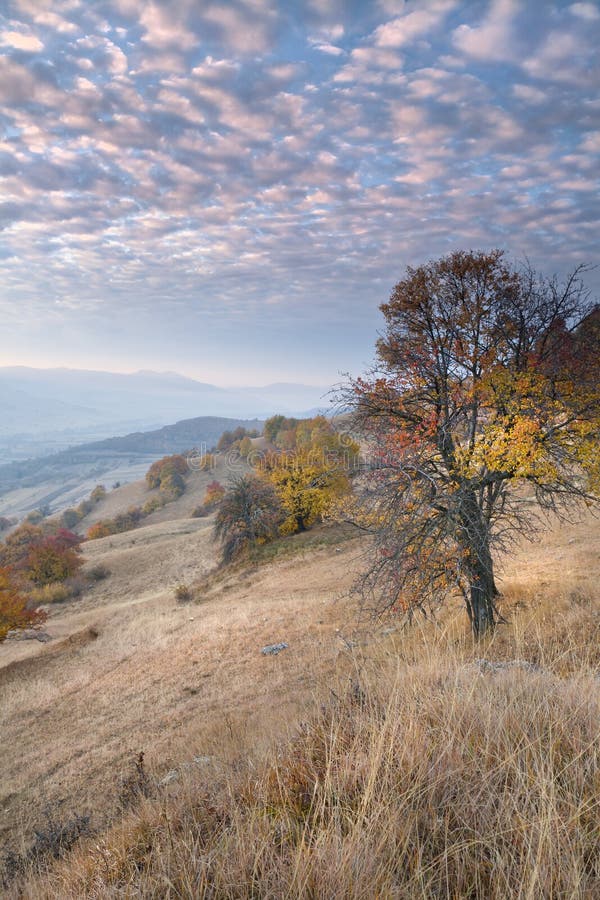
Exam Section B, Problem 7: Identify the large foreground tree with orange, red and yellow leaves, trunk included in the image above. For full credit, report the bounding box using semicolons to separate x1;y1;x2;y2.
344;250;600;635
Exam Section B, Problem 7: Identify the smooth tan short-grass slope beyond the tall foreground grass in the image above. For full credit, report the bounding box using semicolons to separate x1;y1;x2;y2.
0;471;364;864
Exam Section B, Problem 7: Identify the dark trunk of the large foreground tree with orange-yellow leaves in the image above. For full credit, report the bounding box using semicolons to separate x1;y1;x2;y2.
460;492;498;638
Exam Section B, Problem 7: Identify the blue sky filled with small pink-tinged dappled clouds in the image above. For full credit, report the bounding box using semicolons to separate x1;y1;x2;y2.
0;0;600;385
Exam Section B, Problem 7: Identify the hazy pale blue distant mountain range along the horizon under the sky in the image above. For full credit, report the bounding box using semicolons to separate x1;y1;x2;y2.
0;366;329;462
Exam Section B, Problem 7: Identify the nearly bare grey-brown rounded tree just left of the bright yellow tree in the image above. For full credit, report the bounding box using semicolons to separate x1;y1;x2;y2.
214;475;281;562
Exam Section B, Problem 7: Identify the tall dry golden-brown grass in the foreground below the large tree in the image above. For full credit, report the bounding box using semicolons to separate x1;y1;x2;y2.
14;584;600;900
